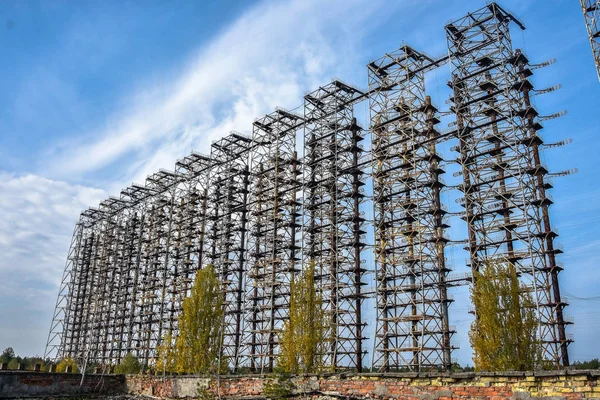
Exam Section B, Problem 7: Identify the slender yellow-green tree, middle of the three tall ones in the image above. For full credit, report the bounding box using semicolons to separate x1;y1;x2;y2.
277;264;325;373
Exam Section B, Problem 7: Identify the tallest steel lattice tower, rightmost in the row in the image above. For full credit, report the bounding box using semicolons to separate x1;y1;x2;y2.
446;3;569;365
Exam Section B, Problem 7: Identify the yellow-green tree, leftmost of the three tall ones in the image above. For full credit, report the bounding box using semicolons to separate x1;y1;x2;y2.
157;266;224;374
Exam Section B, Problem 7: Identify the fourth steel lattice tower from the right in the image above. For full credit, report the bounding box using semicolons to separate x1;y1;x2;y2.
244;109;303;372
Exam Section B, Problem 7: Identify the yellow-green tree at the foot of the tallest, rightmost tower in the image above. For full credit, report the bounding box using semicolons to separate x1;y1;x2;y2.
469;262;541;371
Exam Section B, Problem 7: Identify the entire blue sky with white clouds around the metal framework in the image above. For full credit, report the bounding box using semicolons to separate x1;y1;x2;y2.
0;0;600;364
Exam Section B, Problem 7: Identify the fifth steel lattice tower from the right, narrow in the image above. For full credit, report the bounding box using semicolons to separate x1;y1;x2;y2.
207;133;252;370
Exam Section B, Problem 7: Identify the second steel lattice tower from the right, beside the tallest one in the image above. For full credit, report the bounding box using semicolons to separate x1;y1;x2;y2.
368;46;454;371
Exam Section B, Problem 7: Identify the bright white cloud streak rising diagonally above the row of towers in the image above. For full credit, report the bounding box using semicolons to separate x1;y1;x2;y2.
52;0;390;190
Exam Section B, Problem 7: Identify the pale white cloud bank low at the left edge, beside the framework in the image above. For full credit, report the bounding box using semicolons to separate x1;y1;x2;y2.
0;172;106;354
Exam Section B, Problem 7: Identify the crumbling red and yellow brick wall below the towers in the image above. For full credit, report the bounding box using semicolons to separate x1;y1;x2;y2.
127;371;600;400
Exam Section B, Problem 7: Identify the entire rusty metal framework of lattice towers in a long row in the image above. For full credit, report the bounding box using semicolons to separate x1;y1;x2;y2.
45;2;572;373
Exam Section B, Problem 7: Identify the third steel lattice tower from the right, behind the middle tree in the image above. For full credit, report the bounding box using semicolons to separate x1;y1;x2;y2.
304;81;366;371
